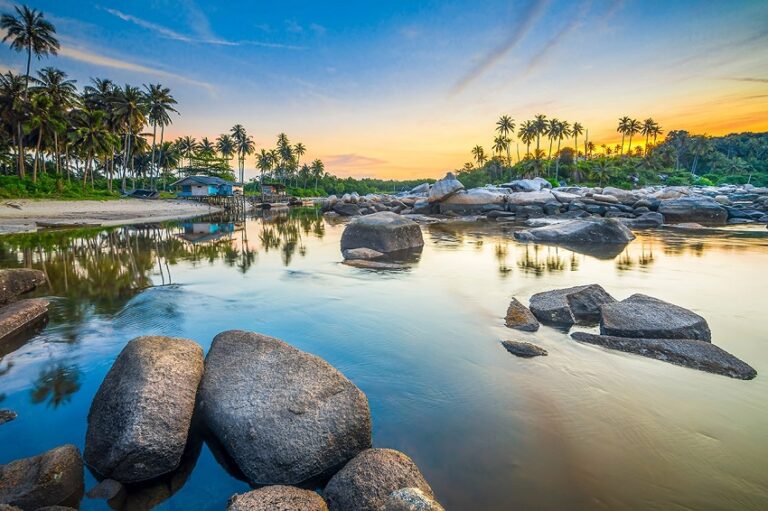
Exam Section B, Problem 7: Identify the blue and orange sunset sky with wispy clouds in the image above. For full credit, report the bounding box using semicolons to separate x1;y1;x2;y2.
0;0;768;179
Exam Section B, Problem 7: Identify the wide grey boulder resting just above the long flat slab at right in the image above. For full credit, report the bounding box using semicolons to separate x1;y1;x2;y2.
600;293;712;341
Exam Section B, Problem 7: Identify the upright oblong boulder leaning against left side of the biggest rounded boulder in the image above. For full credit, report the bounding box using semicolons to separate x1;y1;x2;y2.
85;336;203;483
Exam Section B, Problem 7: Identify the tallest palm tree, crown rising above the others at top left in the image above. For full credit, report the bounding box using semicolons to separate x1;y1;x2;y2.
0;5;59;92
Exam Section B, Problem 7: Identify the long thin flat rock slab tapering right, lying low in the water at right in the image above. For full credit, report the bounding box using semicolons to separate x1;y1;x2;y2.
571;332;757;380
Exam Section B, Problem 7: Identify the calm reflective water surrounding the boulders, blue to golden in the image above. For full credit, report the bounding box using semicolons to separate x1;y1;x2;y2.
0;210;768;510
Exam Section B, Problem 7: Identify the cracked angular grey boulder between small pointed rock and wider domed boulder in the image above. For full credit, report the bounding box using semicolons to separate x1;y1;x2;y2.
530;284;616;327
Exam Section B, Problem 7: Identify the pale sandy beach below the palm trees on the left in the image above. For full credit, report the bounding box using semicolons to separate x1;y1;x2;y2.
0;199;220;234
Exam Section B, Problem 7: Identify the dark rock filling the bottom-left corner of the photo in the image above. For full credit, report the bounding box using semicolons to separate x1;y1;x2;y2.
0;445;84;509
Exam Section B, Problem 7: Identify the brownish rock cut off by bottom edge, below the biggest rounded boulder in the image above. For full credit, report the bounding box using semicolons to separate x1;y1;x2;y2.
227;486;328;511
